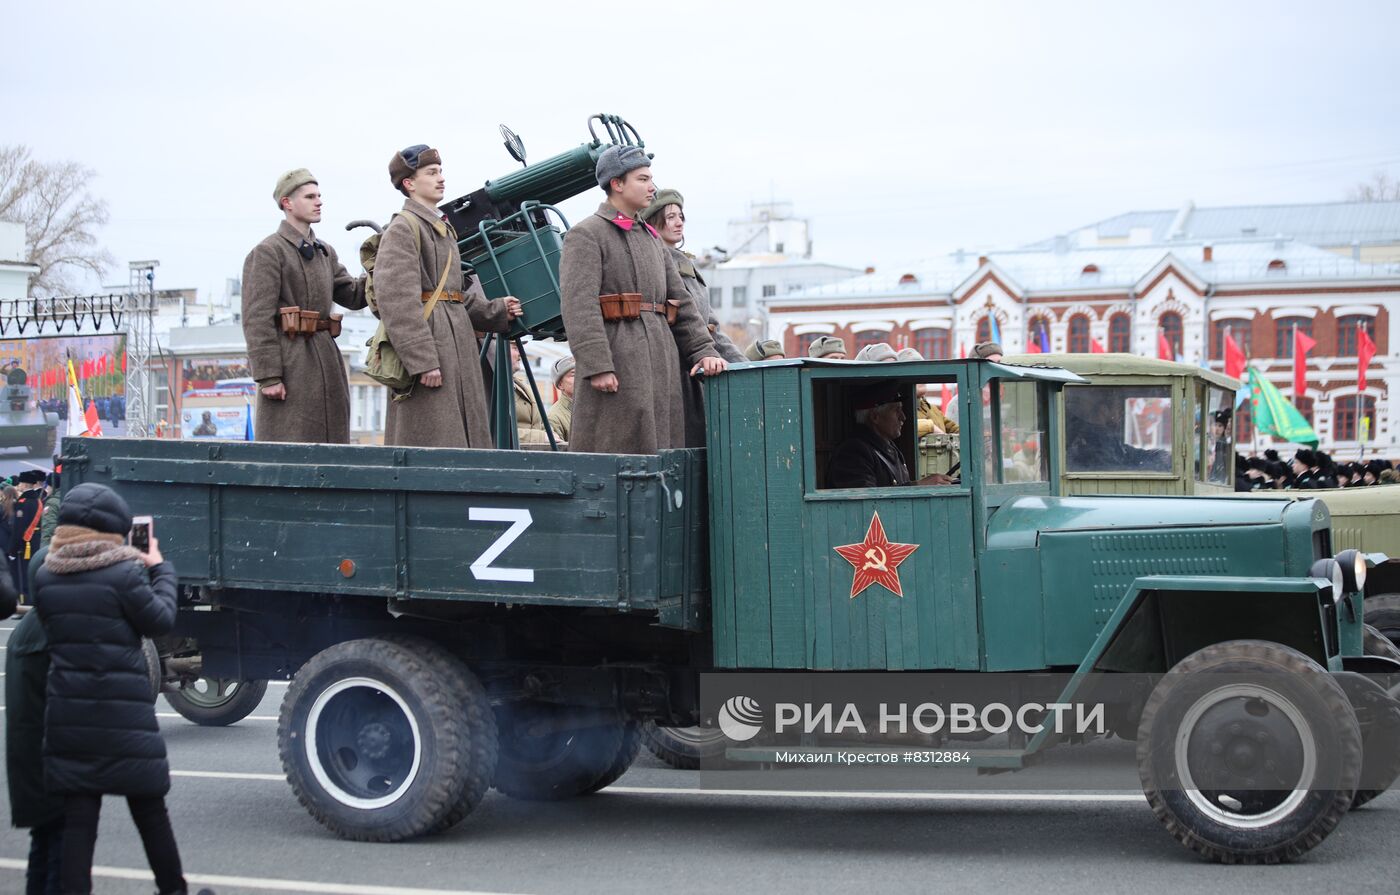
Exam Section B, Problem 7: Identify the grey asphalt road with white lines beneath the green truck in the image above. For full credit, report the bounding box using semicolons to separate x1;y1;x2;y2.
0;620;1400;895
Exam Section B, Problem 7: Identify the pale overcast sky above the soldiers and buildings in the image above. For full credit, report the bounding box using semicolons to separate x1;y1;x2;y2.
0;0;1400;301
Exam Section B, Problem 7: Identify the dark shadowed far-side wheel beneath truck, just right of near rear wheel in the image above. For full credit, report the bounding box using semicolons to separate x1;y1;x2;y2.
494;706;624;801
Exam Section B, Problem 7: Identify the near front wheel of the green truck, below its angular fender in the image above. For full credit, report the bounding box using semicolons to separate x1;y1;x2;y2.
1137;640;1362;864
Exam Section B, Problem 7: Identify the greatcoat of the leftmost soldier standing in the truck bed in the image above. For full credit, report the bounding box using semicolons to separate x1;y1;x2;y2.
244;221;365;444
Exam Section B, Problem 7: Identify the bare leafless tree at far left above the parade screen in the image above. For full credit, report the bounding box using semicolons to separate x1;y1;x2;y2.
0;146;113;296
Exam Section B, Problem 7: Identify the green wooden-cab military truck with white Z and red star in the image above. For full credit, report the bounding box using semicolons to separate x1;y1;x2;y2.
64;360;1400;863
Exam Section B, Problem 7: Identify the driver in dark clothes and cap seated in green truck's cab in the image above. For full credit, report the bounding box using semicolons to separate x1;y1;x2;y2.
827;382;955;487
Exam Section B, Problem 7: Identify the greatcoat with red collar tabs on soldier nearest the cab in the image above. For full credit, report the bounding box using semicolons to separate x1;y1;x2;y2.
559;202;720;454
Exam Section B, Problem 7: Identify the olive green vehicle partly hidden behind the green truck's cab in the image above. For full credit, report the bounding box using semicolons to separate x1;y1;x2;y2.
1002;354;1400;643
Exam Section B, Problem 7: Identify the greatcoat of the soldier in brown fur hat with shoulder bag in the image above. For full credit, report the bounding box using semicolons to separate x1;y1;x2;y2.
374;199;510;448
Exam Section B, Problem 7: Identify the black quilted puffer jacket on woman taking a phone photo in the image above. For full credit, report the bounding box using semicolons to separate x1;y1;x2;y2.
35;526;175;796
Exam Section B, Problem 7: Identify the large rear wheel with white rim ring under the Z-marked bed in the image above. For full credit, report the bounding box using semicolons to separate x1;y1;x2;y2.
277;637;497;842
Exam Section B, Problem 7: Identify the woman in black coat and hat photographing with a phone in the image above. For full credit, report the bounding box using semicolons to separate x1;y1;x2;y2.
34;483;210;894
